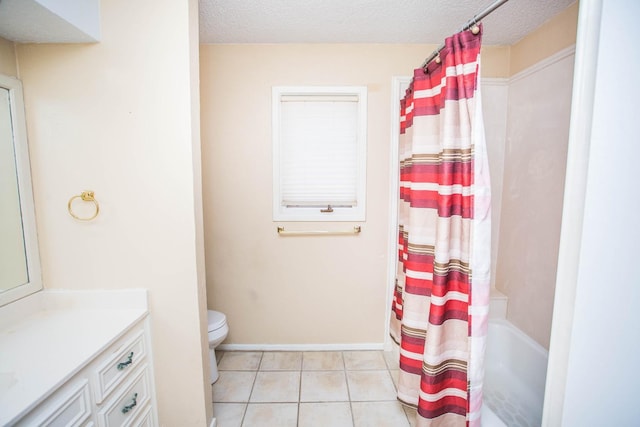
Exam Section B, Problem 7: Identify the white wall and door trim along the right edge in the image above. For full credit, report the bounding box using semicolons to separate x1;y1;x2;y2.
543;0;640;427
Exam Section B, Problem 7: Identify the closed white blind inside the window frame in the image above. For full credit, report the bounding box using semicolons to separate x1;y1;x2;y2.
280;94;358;207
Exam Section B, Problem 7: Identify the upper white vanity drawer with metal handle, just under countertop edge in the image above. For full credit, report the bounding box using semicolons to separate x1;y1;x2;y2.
95;331;146;404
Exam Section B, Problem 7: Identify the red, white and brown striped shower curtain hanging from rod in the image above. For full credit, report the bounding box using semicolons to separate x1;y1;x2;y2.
390;27;491;427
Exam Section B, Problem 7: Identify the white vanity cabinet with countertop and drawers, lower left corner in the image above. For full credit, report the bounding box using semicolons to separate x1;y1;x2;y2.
0;294;158;427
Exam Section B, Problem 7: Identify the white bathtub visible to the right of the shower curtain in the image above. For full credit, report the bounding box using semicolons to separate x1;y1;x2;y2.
482;319;548;427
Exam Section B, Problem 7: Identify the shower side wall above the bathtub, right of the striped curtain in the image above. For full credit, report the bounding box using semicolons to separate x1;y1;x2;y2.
495;4;577;348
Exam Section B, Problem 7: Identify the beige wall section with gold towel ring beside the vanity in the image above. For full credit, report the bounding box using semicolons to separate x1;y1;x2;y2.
17;0;211;427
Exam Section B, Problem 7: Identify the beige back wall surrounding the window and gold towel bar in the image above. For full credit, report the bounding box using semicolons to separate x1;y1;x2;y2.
200;44;508;346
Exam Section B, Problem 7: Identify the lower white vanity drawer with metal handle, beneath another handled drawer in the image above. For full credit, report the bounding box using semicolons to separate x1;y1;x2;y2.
98;364;151;427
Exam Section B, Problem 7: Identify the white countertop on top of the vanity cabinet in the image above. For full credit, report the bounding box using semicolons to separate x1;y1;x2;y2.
0;289;148;425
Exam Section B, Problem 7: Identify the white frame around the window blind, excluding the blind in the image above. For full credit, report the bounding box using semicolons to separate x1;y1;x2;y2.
272;86;368;222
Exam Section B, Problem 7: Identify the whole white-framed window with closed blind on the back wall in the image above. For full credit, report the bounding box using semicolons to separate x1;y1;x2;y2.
273;86;367;221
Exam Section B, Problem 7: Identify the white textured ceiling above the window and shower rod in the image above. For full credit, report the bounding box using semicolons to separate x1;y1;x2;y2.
200;0;575;45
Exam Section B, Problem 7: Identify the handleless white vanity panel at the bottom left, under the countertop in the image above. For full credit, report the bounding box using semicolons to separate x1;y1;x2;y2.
18;379;91;427
